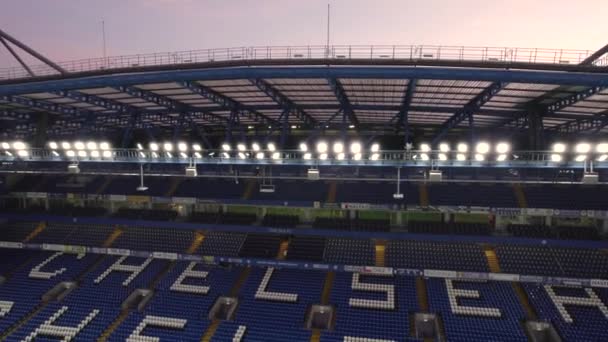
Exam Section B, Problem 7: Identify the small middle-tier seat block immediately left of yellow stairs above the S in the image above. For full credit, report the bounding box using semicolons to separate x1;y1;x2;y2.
324;238;375;266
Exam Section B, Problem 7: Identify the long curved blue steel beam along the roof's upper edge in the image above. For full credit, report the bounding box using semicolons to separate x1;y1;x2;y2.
0;66;608;96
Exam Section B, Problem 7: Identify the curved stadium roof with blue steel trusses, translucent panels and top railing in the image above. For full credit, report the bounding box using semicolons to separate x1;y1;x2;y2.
0;46;608;146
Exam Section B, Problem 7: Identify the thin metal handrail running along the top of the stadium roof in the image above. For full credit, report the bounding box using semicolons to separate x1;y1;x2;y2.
0;45;608;80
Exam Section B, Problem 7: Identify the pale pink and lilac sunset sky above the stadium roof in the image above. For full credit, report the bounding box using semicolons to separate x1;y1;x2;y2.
0;0;608;67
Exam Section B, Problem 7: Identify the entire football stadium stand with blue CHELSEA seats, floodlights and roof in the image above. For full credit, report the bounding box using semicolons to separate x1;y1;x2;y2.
0;2;608;342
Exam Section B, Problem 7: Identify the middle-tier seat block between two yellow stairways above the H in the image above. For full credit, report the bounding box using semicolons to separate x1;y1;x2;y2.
112;227;194;253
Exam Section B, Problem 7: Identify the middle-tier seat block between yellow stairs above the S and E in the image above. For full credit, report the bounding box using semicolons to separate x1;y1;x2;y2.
386;240;488;272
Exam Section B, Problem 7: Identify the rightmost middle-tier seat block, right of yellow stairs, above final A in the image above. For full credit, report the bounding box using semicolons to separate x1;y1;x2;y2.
496;245;608;279
